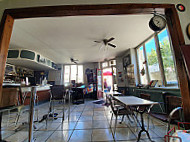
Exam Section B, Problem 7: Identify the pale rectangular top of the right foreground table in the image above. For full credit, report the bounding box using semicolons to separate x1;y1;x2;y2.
114;96;158;106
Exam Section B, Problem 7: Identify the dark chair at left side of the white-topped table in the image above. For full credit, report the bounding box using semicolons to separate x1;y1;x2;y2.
108;95;135;136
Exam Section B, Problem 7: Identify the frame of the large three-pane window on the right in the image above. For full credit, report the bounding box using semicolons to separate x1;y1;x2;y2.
135;28;179;87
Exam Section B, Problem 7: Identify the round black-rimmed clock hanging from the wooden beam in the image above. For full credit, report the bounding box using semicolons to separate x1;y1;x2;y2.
149;15;166;32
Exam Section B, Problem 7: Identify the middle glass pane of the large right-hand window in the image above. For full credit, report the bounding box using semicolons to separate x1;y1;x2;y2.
145;38;162;82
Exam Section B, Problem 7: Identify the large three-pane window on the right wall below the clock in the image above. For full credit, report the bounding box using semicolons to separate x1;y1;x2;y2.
136;29;177;86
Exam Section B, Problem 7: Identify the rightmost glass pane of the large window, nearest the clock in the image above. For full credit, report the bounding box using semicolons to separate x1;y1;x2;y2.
158;29;177;84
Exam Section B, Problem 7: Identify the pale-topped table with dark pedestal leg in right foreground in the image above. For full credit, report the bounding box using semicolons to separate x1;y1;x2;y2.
113;96;159;141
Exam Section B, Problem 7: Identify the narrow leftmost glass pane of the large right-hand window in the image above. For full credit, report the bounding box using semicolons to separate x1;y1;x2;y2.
137;46;148;84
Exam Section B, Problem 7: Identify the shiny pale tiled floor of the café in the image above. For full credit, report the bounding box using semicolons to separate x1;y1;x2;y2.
2;100;166;142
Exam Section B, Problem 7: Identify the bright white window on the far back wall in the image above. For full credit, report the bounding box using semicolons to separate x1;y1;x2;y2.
64;65;83;84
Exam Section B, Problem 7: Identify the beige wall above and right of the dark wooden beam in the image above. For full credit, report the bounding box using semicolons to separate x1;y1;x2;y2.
0;0;190;44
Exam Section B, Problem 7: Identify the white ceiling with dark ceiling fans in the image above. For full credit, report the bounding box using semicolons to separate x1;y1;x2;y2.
10;15;153;64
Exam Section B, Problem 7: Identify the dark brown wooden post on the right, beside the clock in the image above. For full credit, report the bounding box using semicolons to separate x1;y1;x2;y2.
166;7;190;122
